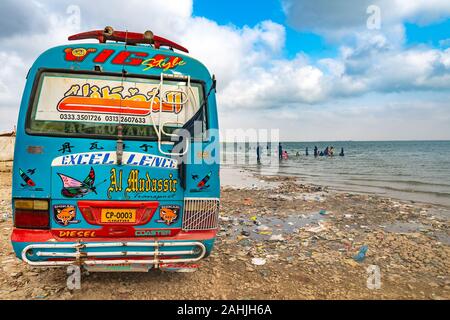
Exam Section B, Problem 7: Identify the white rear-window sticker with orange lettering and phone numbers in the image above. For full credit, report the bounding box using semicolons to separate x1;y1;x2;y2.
34;74;200;127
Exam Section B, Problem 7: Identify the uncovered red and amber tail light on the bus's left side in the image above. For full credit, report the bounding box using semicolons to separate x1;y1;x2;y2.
14;199;50;229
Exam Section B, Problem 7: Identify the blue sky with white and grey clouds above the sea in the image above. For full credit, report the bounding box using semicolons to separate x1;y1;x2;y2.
0;0;450;141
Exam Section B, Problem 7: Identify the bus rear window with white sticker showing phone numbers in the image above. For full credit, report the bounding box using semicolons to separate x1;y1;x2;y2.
27;72;206;140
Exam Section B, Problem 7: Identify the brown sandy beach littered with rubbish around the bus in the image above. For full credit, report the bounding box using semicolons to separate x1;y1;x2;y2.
0;168;450;299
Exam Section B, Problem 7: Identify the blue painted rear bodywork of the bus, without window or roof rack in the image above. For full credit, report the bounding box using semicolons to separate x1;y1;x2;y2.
12;43;220;271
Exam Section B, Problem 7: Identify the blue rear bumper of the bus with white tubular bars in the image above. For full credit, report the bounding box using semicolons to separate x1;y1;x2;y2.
13;229;214;272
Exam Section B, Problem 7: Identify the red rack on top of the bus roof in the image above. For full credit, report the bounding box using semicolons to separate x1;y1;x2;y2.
69;26;189;53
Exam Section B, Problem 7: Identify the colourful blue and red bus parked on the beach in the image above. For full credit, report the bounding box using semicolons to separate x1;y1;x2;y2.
11;27;220;272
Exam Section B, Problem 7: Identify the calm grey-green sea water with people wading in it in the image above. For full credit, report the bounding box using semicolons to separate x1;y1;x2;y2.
222;141;450;207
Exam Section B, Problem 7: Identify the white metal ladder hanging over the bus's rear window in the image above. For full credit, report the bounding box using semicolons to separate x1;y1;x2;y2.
150;73;197;156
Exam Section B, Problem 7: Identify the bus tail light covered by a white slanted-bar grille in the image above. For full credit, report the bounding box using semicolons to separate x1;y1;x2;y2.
182;198;219;231
